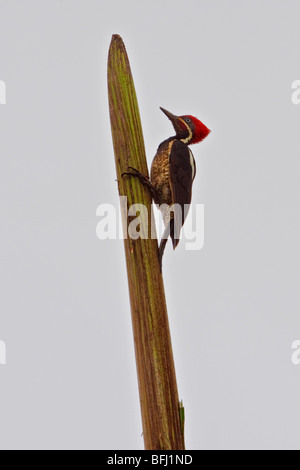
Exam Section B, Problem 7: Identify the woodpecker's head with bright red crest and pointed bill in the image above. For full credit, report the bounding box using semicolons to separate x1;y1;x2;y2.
160;108;210;145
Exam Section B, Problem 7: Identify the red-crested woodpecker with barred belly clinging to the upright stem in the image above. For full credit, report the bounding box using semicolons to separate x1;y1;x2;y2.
124;108;210;267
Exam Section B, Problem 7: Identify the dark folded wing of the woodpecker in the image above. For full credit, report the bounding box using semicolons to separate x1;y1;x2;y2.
169;140;196;248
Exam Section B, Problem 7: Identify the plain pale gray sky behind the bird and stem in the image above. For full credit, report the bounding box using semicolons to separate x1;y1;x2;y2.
0;0;300;449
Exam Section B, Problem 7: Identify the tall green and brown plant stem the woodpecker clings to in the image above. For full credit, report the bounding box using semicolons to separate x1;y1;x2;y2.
108;35;184;450
